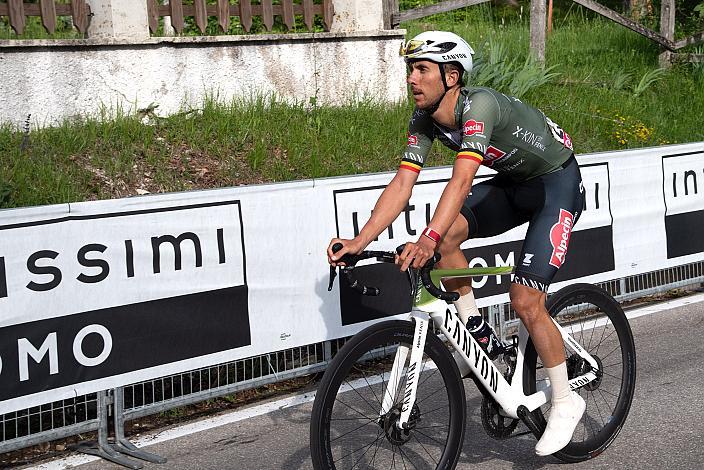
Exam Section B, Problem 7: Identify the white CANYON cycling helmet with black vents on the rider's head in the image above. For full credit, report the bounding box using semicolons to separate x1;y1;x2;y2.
401;31;474;74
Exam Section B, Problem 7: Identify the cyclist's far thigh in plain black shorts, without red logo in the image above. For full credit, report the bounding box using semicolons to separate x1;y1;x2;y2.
460;176;530;238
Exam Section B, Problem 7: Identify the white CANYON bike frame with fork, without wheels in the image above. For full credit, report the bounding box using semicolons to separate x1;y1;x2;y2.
379;270;599;429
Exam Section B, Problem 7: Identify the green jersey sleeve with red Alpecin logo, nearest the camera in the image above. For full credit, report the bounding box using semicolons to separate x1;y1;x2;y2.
457;91;500;163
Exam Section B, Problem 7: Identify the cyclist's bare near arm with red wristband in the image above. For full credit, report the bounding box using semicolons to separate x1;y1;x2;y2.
398;158;479;271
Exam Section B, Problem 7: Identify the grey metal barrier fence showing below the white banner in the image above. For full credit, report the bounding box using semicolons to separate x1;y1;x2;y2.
0;261;704;468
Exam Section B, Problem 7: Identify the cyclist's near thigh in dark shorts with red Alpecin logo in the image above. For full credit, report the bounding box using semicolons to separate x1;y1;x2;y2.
513;161;584;292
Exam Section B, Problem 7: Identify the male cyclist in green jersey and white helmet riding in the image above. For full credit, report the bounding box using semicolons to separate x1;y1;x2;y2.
328;31;586;455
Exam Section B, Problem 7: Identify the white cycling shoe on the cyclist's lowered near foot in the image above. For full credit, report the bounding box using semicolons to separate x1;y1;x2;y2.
535;392;587;456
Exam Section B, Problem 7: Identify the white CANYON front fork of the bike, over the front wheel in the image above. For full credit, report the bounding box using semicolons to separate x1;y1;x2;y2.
379;310;430;429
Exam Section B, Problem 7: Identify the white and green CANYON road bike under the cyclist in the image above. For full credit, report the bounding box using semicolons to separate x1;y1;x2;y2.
310;246;636;469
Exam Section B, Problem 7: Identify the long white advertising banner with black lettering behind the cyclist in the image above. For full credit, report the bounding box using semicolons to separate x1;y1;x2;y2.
0;143;704;414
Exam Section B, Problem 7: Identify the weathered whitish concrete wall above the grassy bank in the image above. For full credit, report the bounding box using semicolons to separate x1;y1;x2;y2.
0;30;406;126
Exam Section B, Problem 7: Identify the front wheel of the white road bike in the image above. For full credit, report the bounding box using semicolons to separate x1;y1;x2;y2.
310;321;466;470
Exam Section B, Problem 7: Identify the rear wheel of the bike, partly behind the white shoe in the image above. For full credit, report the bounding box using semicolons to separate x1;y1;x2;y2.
524;284;636;462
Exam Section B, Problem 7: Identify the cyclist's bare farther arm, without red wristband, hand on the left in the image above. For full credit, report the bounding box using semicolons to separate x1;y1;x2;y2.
328;168;420;266
